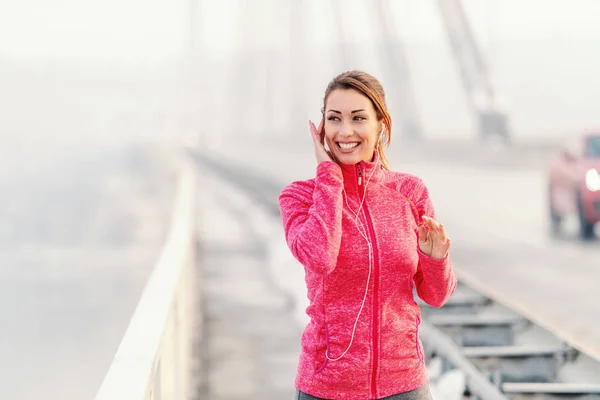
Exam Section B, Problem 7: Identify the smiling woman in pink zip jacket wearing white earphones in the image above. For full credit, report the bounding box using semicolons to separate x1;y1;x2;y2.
279;71;456;400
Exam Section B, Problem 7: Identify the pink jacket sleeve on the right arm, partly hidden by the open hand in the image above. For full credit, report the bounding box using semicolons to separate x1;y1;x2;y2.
413;177;457;307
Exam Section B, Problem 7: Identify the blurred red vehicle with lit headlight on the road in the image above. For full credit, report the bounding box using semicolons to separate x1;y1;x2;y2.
548;133;600;239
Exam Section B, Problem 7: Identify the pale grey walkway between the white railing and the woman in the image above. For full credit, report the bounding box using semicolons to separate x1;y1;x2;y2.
198;173;301;400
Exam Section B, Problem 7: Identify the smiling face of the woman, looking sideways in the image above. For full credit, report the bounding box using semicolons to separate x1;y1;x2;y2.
324;89;382;165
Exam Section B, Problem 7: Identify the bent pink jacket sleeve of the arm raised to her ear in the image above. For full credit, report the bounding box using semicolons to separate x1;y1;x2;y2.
279;161;343;275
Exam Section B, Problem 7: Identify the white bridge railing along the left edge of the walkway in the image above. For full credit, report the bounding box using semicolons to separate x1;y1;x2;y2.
96;159;199;400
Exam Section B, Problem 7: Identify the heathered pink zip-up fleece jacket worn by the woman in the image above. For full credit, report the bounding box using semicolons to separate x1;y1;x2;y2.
279;152;456;400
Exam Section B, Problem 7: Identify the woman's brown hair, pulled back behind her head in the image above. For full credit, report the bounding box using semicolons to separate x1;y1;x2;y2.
322;70;392;170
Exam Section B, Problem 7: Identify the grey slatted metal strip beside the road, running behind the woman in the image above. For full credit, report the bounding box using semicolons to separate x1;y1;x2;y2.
193;151;600;400
